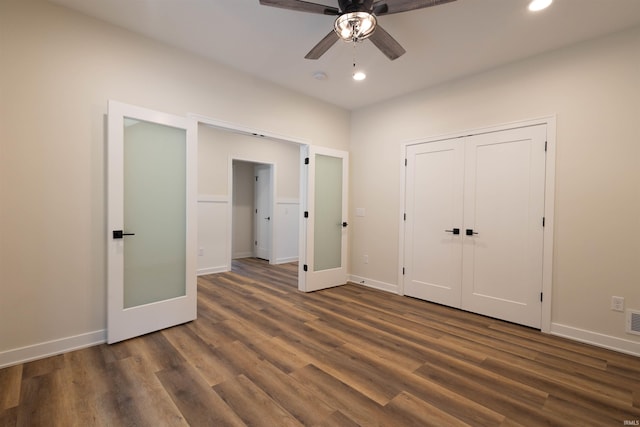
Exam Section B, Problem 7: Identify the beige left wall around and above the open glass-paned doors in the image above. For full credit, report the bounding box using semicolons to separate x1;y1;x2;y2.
0;0;349;358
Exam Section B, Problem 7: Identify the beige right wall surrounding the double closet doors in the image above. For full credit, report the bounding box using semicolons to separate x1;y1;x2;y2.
350;28;640;354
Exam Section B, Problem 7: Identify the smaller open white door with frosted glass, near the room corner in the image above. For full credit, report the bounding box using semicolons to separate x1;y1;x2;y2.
299;146;349;292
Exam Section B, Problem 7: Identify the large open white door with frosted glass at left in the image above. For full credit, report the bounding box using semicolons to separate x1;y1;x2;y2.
107;101;197;343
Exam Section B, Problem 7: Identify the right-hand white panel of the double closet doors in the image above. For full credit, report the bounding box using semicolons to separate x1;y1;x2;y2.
461;125;546;328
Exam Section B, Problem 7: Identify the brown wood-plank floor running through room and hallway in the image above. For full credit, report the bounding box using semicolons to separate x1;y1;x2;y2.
0;259;640;427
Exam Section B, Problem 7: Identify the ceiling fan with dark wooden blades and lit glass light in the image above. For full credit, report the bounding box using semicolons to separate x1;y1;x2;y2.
260;0;455;61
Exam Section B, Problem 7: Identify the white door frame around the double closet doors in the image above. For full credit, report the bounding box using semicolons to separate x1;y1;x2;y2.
397;115;556;333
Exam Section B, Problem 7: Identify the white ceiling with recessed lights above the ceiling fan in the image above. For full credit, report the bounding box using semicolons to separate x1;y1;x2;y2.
49;0;640;109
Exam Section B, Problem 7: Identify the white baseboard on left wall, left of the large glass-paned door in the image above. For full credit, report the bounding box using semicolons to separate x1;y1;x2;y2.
0;329;107;368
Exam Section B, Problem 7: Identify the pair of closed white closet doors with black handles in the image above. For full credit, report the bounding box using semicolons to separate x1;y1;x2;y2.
404;125;546;328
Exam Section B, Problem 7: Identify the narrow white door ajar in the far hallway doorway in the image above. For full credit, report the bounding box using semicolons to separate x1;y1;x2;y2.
254;165;273;261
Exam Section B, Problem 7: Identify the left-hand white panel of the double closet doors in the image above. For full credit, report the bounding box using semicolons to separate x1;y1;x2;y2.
404;139;464;307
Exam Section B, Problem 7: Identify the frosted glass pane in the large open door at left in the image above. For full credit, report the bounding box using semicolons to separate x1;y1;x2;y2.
124;118;187;308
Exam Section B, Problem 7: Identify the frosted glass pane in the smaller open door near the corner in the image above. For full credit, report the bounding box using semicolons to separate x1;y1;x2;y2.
313;154;342;271
